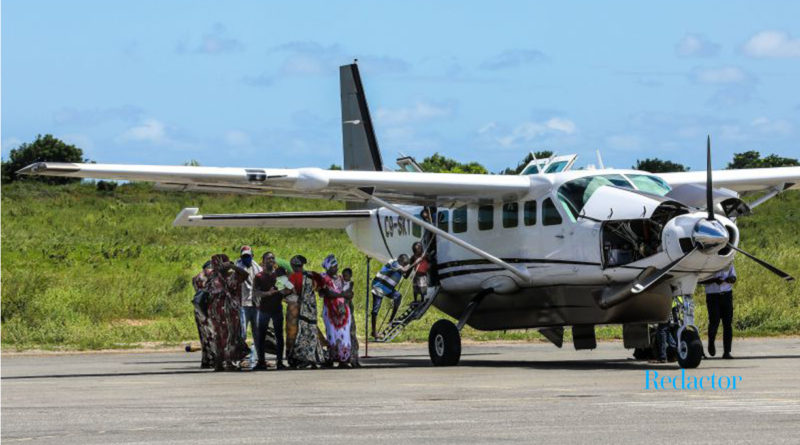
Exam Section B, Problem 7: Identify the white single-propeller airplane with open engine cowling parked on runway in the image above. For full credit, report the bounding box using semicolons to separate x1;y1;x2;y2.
19;63;800;368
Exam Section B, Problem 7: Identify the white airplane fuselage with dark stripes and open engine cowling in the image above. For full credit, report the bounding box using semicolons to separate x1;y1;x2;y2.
347;170;738;330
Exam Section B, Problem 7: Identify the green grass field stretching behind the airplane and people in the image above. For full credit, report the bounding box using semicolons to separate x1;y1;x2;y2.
1;182;800;350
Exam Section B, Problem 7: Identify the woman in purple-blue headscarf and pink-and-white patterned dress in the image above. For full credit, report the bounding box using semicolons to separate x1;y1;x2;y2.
319;254;352;367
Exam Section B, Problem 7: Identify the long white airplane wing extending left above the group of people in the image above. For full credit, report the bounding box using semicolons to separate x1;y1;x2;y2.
18;162;536;204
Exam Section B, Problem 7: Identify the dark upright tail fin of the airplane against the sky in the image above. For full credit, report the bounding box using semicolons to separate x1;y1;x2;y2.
339;63;383;171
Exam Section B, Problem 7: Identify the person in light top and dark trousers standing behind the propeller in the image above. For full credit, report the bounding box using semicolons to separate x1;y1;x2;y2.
703;264;736;359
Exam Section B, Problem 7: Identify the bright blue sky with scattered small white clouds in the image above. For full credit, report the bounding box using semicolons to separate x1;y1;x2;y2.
0;0;800;171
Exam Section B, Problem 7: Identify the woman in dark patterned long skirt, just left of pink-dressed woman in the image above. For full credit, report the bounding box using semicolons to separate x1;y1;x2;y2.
286;255;325;368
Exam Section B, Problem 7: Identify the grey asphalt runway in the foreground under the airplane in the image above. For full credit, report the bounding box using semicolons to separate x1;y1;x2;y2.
2;338;800;444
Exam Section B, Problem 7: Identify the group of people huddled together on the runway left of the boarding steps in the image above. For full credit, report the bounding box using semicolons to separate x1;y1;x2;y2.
192;246;359;371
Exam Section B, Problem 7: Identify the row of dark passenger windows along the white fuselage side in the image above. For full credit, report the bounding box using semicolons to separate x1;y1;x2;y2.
436;198;562;233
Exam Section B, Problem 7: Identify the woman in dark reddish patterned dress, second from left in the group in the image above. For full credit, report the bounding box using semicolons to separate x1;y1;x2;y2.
206;254;250;371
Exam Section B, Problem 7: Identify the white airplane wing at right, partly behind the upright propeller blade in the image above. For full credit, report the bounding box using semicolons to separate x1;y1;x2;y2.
658;167;800;193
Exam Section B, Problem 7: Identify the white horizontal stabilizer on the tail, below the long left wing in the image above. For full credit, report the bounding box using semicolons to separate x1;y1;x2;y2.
172;207;372;229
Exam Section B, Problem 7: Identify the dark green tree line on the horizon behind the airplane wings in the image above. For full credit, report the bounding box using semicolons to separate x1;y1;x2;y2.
2;134;800;184
